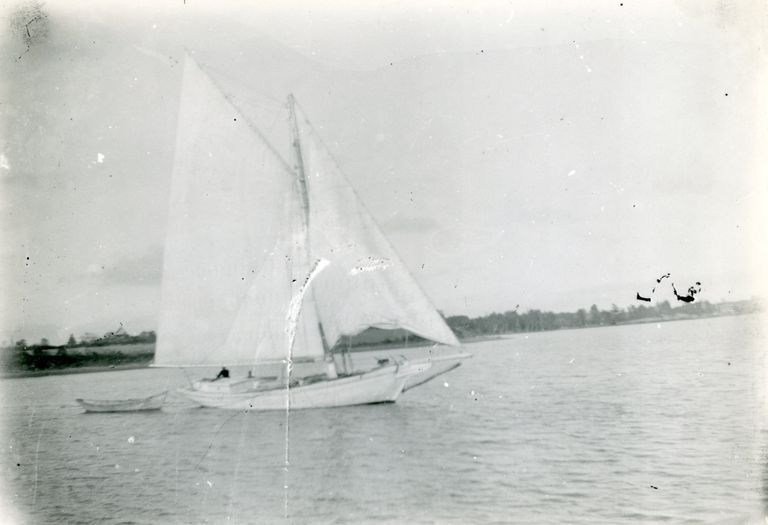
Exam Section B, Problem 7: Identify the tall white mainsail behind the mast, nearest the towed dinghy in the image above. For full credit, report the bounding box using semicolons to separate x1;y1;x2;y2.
155;57;314;366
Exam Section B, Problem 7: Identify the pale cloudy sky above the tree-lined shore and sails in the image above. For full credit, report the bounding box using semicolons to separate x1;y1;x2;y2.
0;0;768;341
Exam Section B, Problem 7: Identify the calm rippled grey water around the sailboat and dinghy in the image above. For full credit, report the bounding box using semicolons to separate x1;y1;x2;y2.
0;316;768;523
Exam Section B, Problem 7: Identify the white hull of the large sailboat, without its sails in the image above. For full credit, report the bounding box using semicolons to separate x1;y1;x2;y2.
178;365;419;410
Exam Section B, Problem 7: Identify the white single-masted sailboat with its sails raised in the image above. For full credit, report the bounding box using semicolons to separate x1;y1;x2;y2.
154;56;469;410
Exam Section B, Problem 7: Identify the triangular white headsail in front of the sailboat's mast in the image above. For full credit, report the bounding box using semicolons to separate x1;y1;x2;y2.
296;102;459;346
